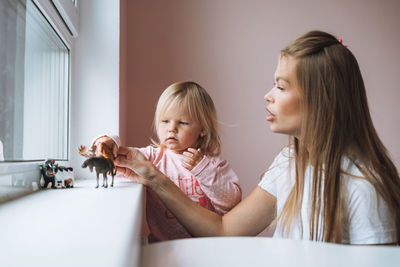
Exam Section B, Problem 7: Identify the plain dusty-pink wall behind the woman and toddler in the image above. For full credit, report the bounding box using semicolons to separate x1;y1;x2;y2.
120;0;400;232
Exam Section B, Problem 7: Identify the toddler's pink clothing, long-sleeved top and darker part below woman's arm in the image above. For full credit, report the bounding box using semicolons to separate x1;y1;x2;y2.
139;146;242;242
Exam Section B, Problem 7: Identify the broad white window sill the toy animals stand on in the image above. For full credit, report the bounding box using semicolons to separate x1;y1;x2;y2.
0;178;143;267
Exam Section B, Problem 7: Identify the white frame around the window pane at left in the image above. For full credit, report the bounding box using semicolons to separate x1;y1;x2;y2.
0;0;78;203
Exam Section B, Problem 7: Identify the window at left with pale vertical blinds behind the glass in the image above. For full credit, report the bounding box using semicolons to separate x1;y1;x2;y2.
0;0;70;200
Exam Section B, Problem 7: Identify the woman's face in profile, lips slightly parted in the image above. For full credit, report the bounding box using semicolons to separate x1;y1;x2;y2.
264;56;302;138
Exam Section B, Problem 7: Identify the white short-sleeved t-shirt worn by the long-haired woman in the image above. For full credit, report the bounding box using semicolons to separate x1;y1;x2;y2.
258;147;397;244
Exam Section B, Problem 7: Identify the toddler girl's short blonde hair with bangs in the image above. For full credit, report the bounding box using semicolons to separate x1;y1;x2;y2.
153;81;221;156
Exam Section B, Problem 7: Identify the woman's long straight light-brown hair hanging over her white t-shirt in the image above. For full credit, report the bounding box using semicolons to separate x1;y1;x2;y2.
280;31;400;243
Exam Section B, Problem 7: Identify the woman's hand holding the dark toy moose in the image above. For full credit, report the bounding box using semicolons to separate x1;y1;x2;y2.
115;147;161;186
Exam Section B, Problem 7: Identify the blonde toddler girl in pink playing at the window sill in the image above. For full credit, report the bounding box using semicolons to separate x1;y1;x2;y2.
94;82;242;242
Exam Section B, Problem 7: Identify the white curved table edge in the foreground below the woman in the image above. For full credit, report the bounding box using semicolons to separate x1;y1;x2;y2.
142;237;400;267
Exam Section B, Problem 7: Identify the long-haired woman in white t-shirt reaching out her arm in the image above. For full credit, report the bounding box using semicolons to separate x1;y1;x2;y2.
116;31;400;244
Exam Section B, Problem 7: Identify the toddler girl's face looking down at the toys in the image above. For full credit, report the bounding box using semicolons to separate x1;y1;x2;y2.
157;105;204;154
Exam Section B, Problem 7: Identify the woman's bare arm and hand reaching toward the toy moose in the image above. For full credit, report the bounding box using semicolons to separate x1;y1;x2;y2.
116;147;276;236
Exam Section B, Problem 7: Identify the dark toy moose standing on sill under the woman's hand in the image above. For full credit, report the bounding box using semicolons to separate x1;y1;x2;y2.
82;156;115;188
